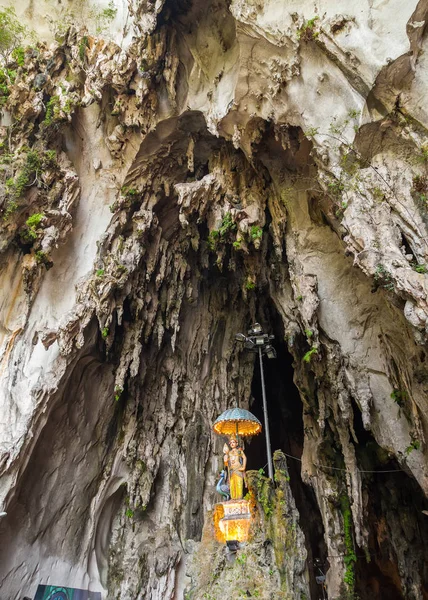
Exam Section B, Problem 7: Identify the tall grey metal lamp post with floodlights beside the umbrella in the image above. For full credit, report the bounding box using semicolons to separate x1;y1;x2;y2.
235;323;276;480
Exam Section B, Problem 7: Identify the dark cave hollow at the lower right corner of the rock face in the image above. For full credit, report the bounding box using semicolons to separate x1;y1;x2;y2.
353;404;428;600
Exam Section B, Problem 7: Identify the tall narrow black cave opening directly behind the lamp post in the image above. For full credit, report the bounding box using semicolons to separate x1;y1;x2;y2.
246;305;327;600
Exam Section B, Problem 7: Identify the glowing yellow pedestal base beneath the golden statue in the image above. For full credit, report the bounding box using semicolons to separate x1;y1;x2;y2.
214;500;251;544
